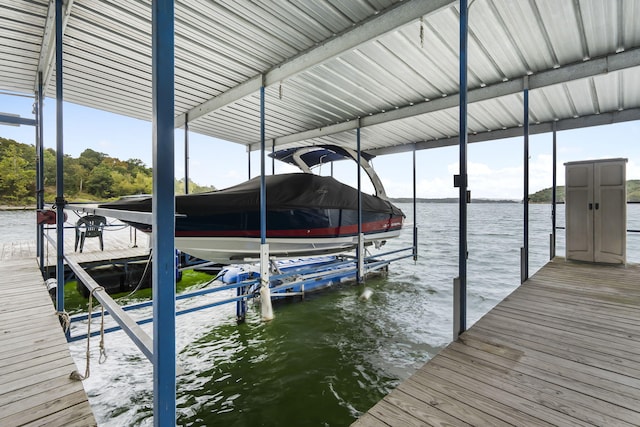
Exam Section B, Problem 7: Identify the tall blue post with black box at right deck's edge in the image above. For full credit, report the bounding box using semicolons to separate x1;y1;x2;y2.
458;0;469;334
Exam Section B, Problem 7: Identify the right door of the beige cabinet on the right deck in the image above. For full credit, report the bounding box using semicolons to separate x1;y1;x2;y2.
593;161;627;264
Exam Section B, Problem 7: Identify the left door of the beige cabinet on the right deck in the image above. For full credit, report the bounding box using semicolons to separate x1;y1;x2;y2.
565;163;594;262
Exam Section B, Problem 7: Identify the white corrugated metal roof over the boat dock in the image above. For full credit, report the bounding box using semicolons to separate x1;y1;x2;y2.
0;0;640;153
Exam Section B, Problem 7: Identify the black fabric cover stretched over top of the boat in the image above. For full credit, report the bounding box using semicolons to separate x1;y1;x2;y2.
100;173;403;215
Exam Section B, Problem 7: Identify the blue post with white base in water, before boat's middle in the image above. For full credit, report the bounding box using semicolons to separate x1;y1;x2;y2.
260;82;274;320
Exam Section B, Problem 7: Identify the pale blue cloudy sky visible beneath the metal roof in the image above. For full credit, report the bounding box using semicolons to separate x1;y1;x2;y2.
0;94;640;199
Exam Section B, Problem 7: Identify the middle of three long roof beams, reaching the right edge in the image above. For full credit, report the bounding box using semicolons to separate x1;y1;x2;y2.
258;49;640;150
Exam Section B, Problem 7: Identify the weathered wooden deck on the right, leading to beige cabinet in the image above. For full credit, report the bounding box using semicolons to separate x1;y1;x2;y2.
353;259;640;427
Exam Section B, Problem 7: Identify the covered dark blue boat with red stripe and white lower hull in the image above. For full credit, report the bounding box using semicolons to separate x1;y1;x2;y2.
100;173;404;264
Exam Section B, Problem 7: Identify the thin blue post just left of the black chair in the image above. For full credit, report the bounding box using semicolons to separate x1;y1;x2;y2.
56;0;69;318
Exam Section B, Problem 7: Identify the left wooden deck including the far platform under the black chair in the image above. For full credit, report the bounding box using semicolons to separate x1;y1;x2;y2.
0;219;149;427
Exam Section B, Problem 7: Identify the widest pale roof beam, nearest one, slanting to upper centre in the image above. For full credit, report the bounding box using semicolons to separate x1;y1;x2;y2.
175;0;457;127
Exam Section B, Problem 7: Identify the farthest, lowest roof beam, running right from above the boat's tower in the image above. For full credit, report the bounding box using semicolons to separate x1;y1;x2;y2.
366;108;640;156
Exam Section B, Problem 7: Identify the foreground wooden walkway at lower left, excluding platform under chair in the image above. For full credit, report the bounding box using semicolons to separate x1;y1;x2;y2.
0;258;96;426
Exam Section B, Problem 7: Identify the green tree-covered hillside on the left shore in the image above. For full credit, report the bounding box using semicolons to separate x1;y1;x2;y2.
0;137;214;205
